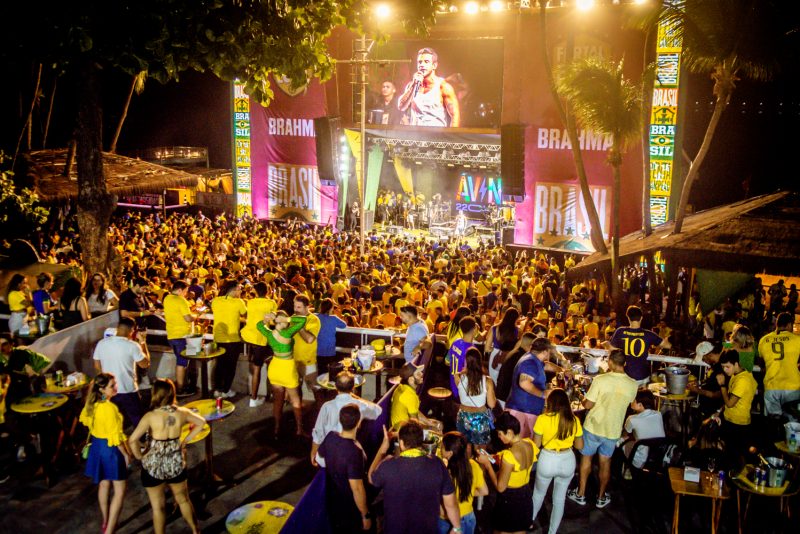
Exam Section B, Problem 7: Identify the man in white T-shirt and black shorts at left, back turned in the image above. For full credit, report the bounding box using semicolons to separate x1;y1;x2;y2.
94;317;150;428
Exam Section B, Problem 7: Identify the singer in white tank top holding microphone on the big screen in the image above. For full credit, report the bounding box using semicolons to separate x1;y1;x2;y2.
397;48;461;127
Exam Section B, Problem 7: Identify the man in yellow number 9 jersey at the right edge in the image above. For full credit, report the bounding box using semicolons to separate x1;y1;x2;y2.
758;312;800;417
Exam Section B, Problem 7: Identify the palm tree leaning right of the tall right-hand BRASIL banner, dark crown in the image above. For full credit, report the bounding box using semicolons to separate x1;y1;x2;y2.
669;0;797;234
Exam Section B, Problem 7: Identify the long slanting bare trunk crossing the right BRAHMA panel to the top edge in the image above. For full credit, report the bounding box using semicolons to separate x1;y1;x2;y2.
539;2;608;254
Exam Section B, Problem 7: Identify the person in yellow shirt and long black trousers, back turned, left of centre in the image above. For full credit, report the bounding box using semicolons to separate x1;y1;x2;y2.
211;280;247;398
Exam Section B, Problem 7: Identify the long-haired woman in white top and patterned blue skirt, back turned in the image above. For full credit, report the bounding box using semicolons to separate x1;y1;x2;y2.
456;347;497;449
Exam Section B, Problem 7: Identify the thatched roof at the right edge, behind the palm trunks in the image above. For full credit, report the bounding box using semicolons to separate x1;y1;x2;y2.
568;191;800;278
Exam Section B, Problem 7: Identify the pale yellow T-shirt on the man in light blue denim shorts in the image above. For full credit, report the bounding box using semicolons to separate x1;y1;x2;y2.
583;373;639;439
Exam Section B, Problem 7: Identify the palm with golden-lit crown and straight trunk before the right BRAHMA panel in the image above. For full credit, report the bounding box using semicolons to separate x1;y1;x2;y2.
557;58;642;307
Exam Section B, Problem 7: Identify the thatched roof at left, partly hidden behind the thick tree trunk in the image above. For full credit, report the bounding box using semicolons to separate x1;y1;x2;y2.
25;149;197;202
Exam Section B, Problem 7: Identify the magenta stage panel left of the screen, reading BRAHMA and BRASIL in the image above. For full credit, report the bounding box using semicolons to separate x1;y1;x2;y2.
250;76;337;225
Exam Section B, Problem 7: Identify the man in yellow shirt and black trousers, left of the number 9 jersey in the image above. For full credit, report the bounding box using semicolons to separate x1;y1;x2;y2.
717;349;758;463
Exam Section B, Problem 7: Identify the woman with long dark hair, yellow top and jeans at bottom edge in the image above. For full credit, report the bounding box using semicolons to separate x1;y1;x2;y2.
439;432;489;534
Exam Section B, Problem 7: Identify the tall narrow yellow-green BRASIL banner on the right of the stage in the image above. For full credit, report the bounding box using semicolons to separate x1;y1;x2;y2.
649;11;682;226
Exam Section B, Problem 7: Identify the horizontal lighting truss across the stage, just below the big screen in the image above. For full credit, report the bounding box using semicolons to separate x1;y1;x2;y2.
370;137;500;169
